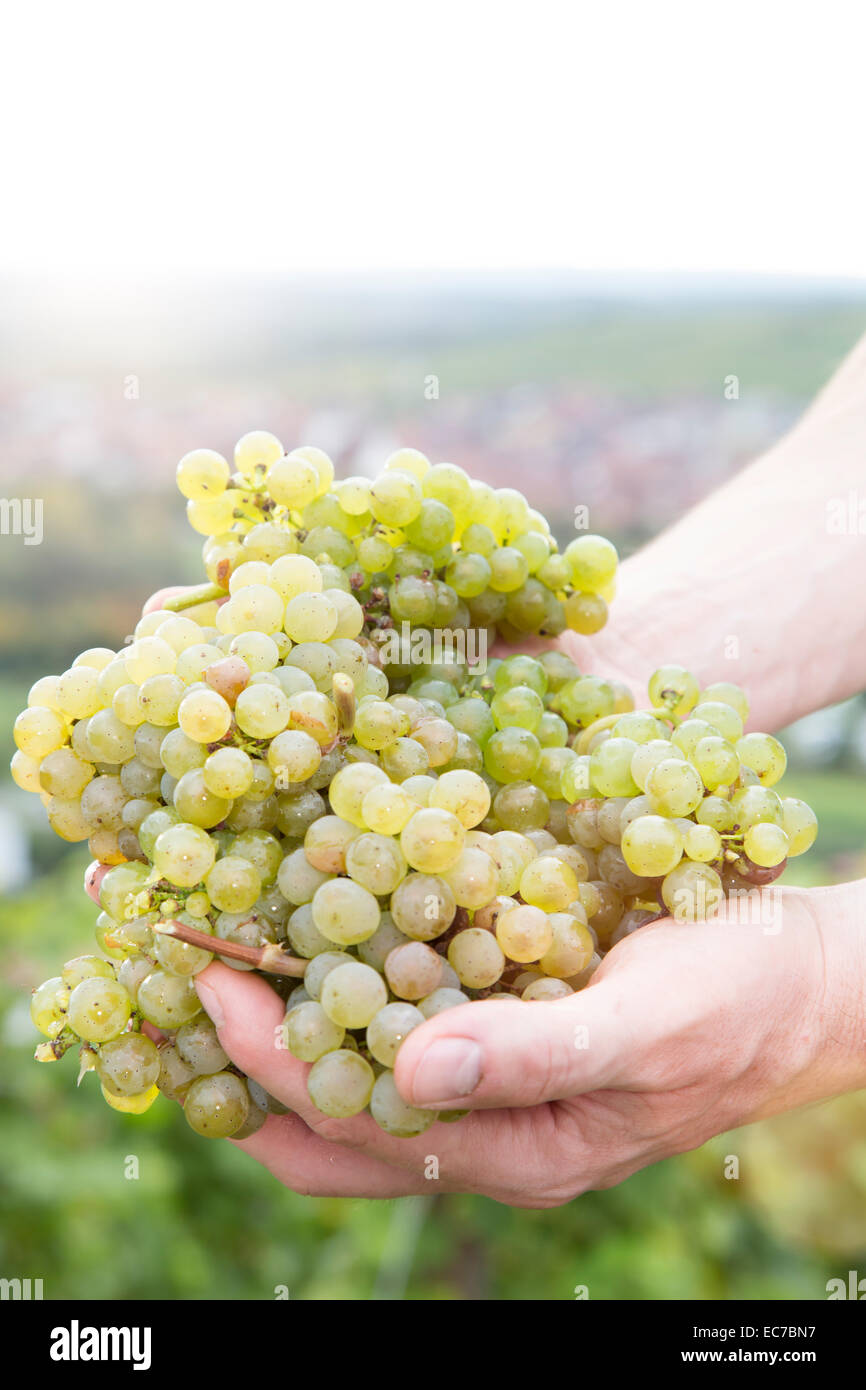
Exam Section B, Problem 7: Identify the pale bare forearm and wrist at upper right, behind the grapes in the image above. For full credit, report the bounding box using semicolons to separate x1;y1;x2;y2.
586;339;866;730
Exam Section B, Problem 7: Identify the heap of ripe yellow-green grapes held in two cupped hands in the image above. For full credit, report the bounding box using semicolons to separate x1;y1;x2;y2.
13;431;817;1138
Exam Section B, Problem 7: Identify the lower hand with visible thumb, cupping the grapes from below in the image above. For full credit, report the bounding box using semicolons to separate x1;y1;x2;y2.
150;883;866;1208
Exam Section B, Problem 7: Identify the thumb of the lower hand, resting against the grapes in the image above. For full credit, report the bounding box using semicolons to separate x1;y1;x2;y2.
395;984;627;1109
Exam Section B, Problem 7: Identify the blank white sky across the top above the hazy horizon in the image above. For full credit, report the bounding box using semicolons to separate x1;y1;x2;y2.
0;0;866;277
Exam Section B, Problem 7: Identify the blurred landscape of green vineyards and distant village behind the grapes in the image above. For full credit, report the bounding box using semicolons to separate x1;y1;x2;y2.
0;271;866;1300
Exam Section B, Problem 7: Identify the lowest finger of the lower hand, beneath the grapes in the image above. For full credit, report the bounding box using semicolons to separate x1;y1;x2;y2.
236;1115;430;1197
